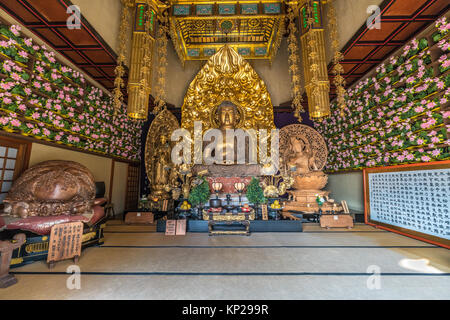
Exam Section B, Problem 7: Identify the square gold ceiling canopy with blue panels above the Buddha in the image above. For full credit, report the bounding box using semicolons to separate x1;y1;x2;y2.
169;0;286;64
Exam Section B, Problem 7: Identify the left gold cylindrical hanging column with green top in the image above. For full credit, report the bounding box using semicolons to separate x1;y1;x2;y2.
128;0;158;119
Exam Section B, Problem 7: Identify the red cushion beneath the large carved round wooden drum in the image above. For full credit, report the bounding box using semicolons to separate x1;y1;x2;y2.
0;201;105;236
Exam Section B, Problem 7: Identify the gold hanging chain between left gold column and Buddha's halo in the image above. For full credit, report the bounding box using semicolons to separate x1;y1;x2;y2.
152;11;169;115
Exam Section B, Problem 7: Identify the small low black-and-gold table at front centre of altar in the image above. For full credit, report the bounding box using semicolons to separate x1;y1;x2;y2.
203;209;255;236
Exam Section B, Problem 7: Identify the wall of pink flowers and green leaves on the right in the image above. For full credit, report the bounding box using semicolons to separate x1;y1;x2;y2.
315;18;450;172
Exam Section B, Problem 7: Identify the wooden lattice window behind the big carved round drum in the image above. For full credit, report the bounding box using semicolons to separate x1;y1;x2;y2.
0;136;31;205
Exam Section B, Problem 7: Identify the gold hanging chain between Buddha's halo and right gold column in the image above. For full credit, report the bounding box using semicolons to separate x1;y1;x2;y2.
287;3;305;122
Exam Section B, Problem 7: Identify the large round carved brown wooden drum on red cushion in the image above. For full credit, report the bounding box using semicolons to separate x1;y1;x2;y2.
4;160;95;218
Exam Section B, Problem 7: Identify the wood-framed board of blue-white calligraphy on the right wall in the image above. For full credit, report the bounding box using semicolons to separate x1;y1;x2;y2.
364;161;450;249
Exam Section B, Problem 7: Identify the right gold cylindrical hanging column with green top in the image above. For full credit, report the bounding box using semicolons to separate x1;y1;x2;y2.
300;0;330;119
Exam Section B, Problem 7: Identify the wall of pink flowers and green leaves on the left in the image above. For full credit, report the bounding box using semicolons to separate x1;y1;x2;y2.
0;25;142;161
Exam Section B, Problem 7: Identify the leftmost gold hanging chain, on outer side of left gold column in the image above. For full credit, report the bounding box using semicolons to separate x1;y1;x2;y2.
114;0;134;115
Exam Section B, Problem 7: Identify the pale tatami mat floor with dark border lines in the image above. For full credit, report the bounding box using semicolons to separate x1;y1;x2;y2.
0;221;450;299
